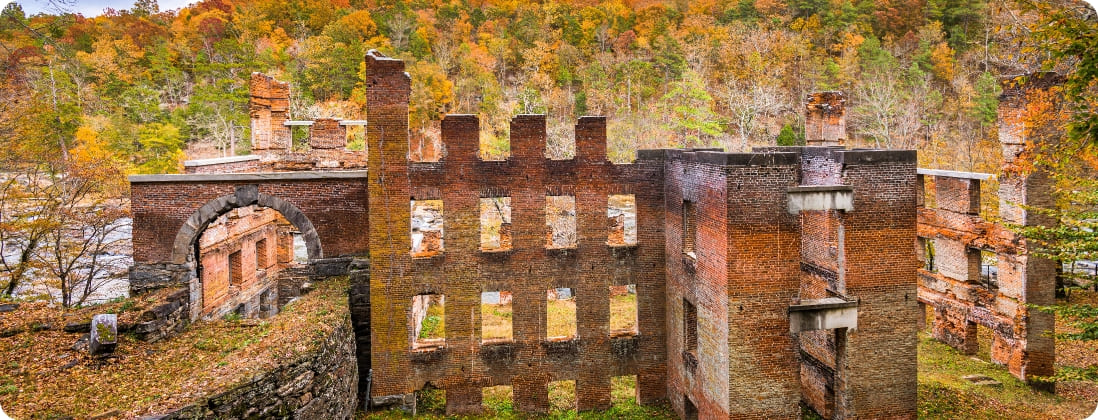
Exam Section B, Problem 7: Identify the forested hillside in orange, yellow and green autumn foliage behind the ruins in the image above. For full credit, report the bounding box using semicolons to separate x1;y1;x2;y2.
0;0;1082;173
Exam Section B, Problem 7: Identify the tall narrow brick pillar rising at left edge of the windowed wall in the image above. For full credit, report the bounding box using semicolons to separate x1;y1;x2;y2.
360;50;416;403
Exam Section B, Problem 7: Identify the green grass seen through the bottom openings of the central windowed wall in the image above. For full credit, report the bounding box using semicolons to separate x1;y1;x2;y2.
355;376;676;420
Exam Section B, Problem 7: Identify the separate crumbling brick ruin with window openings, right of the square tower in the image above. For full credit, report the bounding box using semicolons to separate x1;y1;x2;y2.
918;73;1057;388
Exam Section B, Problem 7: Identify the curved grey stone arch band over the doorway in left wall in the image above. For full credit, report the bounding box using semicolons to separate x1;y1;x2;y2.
171;184;324;264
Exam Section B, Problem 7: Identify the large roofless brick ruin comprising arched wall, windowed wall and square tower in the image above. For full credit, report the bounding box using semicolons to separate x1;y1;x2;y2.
131;52;944;419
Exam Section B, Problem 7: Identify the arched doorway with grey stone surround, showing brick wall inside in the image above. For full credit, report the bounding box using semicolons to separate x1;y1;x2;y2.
171;185;324;320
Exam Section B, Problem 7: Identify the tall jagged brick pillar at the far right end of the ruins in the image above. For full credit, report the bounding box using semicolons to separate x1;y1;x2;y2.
998;73;1060;386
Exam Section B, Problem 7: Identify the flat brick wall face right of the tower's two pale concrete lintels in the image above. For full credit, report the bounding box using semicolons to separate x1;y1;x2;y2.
836;150;918;419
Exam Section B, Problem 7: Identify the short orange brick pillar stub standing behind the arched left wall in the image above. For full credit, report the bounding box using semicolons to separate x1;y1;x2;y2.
248;72;290;154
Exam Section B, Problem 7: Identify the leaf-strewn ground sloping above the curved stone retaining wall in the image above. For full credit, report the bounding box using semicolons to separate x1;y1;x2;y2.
0;279;348;419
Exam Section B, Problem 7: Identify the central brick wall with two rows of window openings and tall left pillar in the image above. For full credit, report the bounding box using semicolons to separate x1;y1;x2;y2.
367;50;665;413
